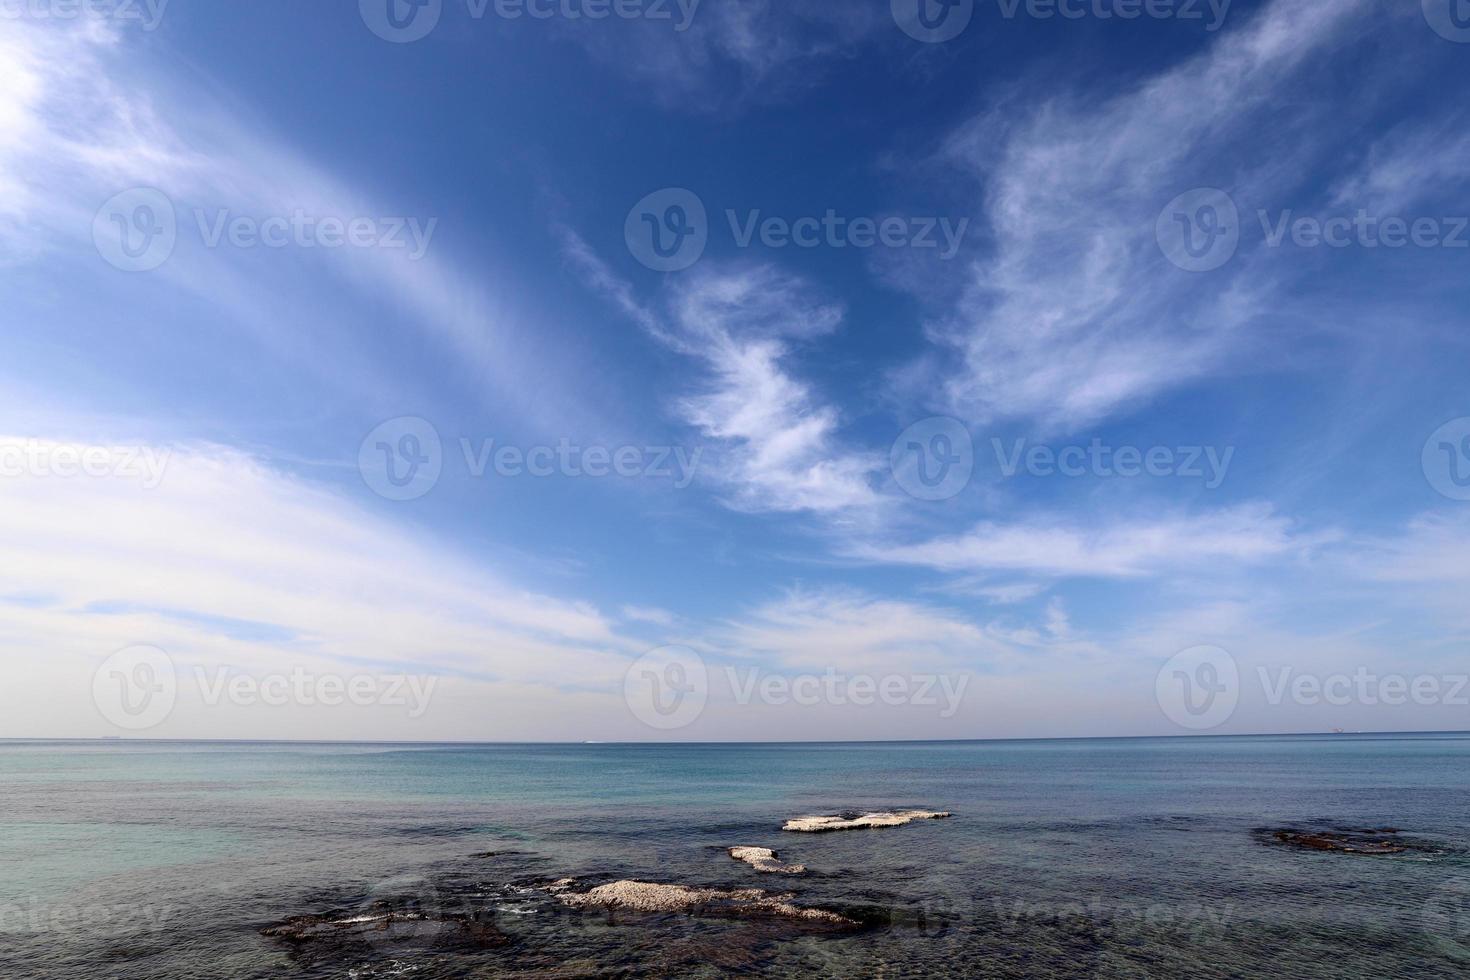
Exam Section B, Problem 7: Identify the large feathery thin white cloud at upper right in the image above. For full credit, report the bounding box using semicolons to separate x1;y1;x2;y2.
935;0;1367;429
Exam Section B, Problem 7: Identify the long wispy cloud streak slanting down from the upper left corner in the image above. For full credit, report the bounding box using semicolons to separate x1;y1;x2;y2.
0;18;607;432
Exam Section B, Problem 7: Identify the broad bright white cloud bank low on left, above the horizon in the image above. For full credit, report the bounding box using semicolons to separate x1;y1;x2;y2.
0;439;658;738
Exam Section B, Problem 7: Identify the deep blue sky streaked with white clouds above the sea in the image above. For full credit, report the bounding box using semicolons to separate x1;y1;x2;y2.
0;0;1470;741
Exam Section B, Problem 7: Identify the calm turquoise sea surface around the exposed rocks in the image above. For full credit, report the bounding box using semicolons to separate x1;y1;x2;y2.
0;735;1470;980
